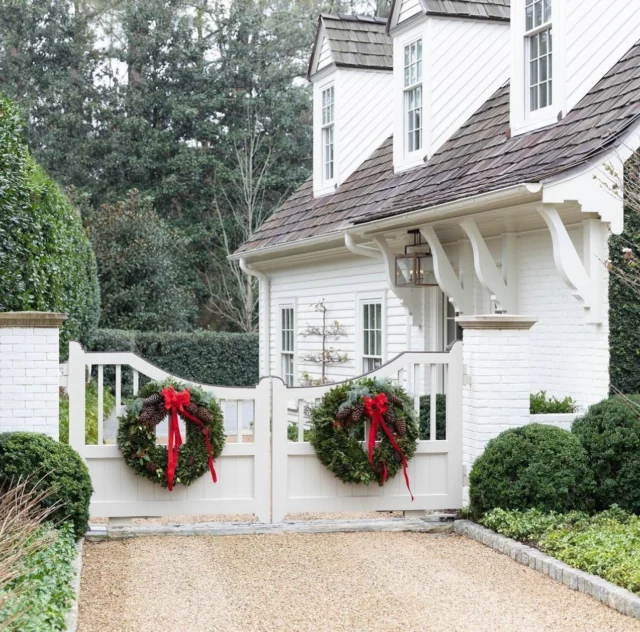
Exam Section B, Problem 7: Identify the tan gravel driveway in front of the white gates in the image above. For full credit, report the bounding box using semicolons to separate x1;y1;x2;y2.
79;533;640;632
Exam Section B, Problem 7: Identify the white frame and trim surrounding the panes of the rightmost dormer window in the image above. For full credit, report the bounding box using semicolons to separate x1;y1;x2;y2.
510;0;566;136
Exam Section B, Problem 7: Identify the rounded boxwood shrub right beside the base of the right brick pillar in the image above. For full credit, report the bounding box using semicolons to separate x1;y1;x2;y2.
469;424;594;517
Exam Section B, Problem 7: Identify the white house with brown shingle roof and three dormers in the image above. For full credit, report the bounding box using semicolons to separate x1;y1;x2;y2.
234;0;640;414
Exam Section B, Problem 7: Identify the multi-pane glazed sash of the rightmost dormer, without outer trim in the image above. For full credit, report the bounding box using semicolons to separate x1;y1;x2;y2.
525;0;553;112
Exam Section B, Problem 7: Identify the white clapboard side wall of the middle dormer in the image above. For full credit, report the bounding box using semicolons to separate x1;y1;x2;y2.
425;18;511;155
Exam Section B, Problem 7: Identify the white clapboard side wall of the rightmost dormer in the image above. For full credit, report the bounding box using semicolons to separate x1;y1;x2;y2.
554;0;640;110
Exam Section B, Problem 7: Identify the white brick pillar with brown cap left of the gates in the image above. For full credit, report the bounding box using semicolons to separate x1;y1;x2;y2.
0;312;65;439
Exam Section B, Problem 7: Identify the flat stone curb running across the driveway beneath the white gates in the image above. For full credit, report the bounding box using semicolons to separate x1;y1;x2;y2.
86;518;453;541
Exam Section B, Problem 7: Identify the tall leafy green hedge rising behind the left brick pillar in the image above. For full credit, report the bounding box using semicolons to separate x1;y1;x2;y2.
0;97;100;358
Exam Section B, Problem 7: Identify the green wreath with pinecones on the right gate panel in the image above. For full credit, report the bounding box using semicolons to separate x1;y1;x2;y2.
310;378;419;485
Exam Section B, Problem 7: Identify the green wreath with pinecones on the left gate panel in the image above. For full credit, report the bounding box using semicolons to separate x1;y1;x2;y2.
118;380;226;488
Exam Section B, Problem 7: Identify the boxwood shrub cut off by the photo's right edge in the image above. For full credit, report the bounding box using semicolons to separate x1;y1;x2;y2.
571;395;640;514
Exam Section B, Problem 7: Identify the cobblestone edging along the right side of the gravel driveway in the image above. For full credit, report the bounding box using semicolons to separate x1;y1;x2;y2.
454;520;640;619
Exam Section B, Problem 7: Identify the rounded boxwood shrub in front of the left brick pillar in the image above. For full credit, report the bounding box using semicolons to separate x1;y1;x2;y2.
0;432;93;538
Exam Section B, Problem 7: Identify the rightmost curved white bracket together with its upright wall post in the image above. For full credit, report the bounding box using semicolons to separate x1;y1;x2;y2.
537;204;606;324
